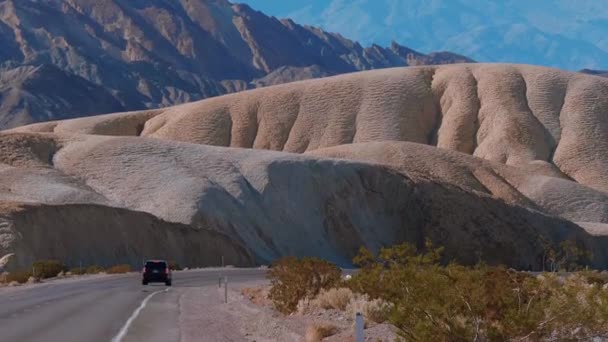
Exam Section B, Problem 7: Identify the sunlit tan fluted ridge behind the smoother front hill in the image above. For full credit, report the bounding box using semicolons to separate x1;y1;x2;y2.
15;64;608;191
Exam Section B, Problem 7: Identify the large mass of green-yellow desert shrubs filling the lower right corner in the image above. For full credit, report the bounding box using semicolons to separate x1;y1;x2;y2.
348;240;608;341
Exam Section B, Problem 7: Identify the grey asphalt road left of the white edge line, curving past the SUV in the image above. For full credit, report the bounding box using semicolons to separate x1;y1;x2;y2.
0;268;265;342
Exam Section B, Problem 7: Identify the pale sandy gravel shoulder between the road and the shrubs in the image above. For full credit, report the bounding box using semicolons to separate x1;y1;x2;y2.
179;281;395;342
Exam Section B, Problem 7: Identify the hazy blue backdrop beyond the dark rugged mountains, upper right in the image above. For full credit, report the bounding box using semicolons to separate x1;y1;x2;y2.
240;0;608;70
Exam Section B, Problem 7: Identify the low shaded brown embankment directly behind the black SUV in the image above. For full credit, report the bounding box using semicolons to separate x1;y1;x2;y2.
0;202;254;270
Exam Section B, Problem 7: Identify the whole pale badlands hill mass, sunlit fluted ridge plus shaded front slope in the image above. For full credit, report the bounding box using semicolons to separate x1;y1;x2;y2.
0;64;608;268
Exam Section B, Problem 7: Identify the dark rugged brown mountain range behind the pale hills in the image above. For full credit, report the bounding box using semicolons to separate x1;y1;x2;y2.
0;0;471;128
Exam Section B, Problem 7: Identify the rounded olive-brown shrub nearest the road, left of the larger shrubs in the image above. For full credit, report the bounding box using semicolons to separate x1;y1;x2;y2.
268;257;341;313
